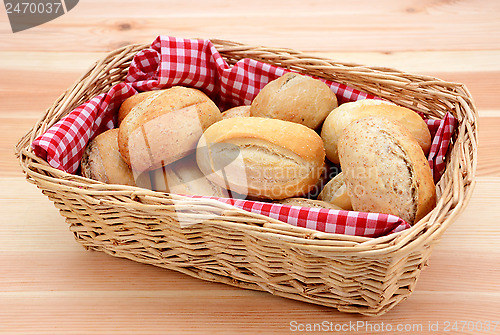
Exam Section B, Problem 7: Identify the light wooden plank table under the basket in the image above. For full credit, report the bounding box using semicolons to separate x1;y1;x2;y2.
0;0;500;335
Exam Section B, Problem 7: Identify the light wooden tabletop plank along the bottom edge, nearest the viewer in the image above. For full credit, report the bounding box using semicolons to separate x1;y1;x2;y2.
0;290;500;335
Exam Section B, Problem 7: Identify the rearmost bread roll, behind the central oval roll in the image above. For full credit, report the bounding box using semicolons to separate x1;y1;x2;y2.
250;72;337;129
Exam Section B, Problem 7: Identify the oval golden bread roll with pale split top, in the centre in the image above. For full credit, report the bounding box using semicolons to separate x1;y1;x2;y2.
196;117;325;199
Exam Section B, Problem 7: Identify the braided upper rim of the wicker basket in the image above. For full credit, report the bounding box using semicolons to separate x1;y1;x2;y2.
16;39;477;256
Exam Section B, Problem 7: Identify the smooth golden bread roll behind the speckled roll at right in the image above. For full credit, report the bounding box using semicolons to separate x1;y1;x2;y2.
321;99;431;164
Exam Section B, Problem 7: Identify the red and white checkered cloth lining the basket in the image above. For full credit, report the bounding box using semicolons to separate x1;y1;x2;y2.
32;36;456;236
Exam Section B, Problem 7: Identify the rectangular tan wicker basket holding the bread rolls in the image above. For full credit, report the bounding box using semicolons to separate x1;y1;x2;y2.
17;40;477;315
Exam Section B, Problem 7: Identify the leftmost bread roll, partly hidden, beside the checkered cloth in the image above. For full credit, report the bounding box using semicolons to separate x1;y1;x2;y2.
81;129;135;186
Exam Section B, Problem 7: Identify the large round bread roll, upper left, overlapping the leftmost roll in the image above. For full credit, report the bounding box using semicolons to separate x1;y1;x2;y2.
118;86;222;173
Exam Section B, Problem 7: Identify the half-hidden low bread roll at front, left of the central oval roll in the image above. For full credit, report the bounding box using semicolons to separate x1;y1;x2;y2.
149;154;228;198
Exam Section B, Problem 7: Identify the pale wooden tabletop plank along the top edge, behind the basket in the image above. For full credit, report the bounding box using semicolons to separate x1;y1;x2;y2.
0;0;500;52
